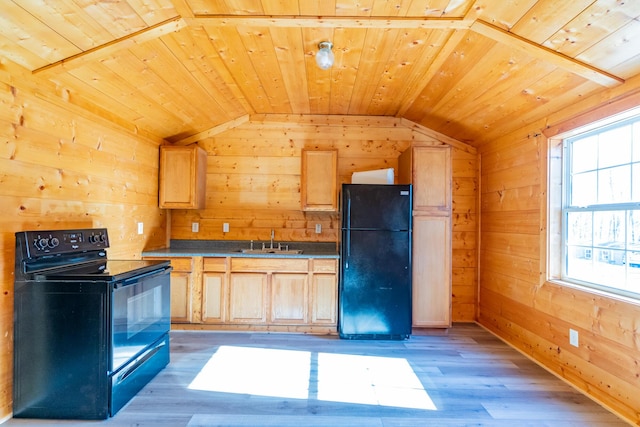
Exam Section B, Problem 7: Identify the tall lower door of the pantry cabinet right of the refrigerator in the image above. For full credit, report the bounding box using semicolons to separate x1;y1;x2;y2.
413;215;452;327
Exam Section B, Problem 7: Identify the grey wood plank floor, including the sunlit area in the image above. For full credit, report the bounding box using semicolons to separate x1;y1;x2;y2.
4;324;628;427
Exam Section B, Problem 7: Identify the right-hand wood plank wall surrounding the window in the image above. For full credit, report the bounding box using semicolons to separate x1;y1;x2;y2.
478;74;640;424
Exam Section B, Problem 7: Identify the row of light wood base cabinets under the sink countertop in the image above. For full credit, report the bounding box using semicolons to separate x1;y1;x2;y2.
145;257;338;331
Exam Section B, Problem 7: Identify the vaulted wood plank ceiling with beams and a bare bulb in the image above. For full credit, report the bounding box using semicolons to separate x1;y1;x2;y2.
0;0;640;145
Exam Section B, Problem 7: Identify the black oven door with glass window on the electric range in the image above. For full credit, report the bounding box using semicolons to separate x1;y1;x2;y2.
111;267;171;372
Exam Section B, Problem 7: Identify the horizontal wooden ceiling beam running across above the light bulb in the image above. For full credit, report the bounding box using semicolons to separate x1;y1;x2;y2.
187;15;472;30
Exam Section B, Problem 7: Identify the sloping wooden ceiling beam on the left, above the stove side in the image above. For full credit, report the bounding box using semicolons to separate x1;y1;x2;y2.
32;16;187;74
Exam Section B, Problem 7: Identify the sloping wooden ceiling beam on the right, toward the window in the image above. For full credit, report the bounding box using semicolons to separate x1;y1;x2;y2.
471;20;624;87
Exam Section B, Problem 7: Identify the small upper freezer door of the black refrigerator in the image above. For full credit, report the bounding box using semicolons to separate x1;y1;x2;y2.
342;184;411;231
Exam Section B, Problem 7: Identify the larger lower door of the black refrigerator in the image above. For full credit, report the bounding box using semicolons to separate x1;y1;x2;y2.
338;230;411;339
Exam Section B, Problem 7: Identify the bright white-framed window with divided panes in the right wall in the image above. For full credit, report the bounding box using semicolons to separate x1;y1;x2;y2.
552;115;640;298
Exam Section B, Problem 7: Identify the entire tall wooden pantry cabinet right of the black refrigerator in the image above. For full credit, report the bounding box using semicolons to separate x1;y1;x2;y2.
398;146;452;328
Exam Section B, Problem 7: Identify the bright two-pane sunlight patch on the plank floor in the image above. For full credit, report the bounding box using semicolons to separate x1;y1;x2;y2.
189;346;437;410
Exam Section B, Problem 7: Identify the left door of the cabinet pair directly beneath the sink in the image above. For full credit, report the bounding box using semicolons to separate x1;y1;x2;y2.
229;273;267;323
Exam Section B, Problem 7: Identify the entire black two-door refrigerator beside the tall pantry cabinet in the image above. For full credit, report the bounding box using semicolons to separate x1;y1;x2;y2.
338;184;412;340
